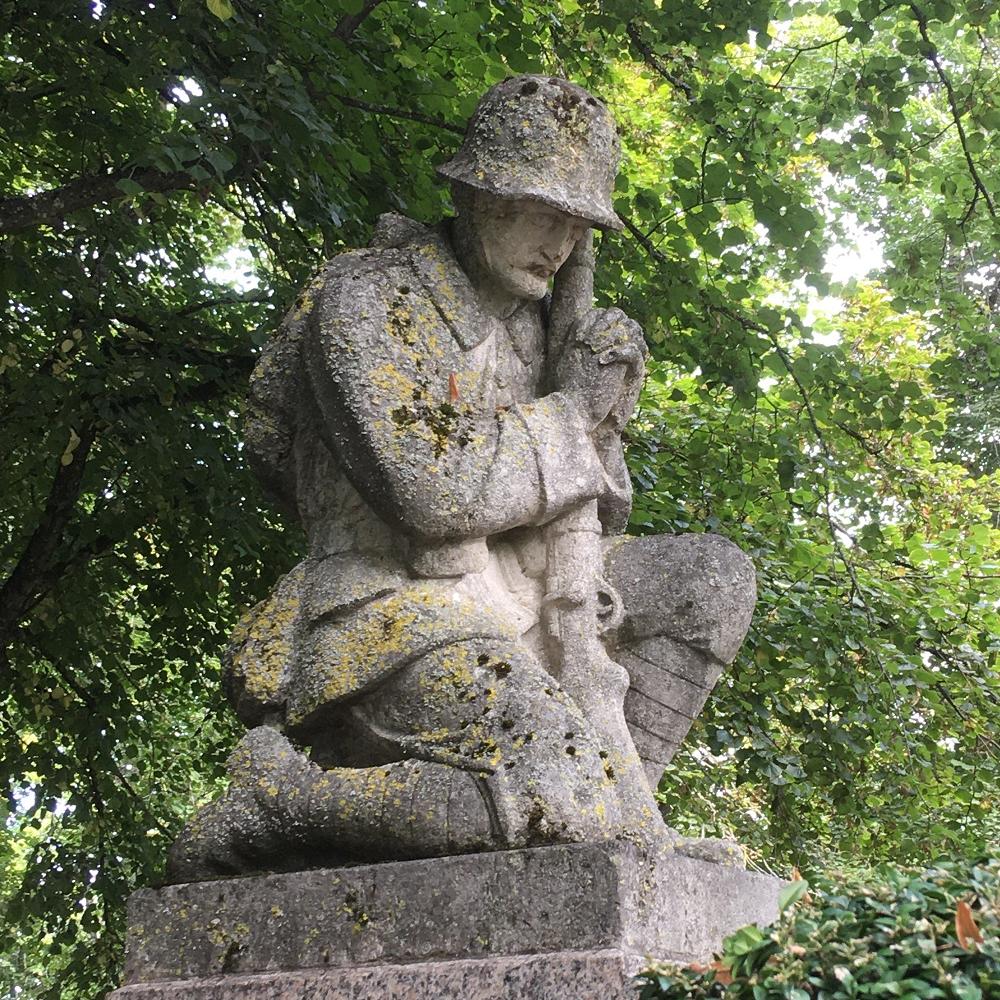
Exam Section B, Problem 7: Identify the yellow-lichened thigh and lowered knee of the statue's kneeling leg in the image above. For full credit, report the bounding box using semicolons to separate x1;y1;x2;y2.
358;638;622;847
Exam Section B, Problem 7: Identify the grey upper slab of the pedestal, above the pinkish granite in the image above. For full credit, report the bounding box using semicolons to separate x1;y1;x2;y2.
116;843;780;998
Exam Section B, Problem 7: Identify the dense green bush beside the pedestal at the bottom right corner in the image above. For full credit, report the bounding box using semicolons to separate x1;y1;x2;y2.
639;859;1000;1000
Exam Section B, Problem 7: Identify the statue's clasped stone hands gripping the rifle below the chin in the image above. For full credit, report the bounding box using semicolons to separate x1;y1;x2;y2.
555;309;647;430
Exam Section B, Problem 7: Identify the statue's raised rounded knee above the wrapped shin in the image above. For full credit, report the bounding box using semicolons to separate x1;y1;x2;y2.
605;534;757;663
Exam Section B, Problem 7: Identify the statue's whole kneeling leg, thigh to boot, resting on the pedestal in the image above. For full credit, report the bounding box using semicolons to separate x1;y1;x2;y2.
168;639;624;881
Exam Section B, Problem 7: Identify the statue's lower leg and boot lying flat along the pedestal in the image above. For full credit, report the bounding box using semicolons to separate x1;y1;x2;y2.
167;726;505;883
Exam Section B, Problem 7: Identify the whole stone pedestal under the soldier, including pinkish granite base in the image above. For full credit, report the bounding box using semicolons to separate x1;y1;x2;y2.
109;843;781;1000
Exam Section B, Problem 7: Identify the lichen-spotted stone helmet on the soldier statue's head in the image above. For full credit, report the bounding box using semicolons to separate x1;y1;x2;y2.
437;76;622;229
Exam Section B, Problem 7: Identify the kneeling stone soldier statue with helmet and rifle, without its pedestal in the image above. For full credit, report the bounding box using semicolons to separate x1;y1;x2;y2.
168;76;755;882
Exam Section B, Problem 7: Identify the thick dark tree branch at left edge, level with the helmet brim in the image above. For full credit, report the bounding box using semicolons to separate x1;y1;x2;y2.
0;167;196;236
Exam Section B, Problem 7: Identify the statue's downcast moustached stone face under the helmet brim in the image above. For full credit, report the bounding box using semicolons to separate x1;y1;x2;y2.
477;198;589;299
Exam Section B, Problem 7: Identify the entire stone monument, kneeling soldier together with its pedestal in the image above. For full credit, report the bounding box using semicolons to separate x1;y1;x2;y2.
115;66;778;1000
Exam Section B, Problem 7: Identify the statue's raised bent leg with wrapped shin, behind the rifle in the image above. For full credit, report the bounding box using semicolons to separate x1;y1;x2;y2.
605;534;756;787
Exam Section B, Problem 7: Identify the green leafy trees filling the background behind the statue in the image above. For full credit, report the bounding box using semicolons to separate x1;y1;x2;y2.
0;0;1000;997
